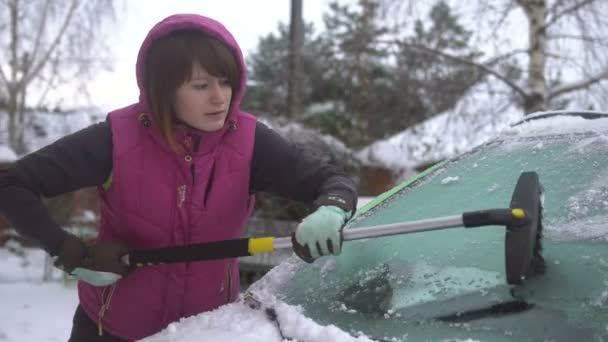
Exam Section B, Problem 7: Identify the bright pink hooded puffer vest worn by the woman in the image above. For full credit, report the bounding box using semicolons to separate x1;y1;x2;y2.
78;15;256;340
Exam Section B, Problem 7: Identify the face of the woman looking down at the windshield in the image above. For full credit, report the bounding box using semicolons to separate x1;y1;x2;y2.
174;64;232;132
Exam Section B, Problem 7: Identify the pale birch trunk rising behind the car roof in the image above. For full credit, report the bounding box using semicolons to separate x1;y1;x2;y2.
517;0;547;114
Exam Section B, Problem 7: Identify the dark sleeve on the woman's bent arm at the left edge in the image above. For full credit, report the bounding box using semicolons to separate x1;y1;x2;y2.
0;122;112;255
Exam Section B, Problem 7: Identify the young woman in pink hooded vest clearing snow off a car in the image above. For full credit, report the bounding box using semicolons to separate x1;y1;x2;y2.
0;14;356;342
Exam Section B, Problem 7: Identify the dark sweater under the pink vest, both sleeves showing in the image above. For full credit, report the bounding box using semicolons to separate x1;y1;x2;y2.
0;121;357;255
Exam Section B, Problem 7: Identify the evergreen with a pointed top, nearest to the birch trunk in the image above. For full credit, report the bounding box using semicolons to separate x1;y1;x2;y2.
395;1;479;126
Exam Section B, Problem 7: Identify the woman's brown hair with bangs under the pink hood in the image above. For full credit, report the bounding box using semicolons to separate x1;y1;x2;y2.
144;30;239;149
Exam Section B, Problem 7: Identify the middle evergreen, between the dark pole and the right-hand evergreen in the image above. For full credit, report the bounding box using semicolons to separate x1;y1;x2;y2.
308;0;391;146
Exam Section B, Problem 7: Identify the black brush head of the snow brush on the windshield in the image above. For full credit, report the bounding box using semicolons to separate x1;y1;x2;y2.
505;172;546;285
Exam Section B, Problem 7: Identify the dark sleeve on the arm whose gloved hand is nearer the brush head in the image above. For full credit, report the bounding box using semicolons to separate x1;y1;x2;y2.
250;122;357;213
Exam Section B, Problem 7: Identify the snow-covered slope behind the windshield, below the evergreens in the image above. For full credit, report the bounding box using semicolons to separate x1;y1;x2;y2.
357;84;523;170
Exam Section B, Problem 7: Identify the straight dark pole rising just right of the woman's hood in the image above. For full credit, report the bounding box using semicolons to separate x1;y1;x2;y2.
287;0;304;118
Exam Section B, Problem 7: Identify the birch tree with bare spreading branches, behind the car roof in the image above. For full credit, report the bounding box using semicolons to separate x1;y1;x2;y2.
383;0;608;113
